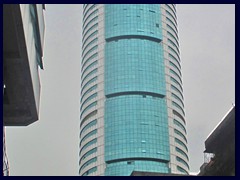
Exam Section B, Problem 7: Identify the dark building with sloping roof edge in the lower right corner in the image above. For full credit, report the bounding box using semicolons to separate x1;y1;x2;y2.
198;106;235;176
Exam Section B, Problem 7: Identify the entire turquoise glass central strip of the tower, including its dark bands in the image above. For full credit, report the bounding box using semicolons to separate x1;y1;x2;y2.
104;4;170;176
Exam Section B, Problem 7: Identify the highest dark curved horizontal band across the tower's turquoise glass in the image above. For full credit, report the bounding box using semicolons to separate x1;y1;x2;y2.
106;35;162;43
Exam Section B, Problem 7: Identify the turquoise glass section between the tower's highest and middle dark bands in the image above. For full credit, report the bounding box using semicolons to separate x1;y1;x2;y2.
105;38;166;96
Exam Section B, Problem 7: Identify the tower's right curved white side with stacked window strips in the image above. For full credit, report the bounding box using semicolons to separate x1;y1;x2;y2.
161;4;189;174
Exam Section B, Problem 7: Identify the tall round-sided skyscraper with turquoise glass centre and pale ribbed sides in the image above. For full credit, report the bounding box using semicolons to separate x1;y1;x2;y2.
79;4;189;176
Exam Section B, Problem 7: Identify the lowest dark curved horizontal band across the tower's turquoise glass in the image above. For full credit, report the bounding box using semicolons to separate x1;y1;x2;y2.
106;157;169;164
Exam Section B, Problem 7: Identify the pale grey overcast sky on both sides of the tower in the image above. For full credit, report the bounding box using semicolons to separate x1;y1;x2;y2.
6;4;235;176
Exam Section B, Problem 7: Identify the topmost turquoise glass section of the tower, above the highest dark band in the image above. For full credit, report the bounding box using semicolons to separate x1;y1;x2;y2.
105;4;162;40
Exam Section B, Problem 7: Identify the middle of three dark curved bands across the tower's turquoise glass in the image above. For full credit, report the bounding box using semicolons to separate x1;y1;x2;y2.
105;91;165;98
